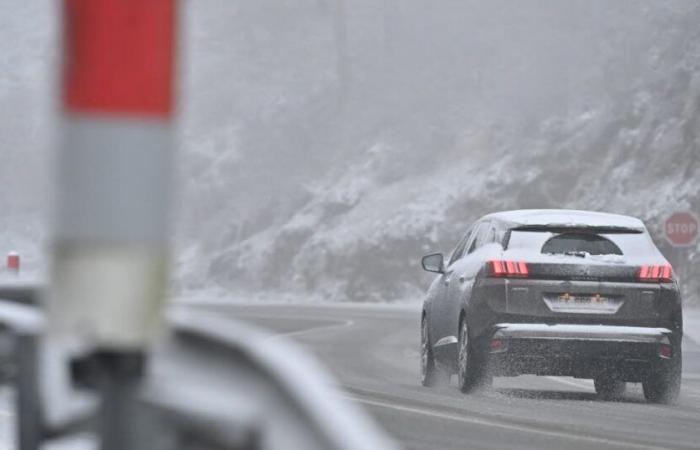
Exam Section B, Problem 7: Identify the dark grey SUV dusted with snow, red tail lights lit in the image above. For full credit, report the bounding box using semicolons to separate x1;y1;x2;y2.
421;210;683;403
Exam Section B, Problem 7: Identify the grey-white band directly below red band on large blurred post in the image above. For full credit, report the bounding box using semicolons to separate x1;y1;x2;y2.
55;116;172;246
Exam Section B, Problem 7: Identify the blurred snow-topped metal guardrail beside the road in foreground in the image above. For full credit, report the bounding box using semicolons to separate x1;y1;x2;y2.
0;286;395;450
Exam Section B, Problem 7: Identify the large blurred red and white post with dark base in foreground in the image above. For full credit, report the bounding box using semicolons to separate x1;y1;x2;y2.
47;0;176;449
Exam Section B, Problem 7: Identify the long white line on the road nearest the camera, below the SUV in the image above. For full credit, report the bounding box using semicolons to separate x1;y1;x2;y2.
345;396;666;450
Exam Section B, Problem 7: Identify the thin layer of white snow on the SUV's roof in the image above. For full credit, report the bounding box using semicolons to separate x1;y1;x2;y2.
484;209;646;231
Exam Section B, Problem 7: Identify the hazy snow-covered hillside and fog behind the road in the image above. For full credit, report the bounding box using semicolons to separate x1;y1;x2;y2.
0;0;700;301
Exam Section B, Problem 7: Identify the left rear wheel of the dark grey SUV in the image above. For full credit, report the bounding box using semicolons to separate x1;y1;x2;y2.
457;320;493;393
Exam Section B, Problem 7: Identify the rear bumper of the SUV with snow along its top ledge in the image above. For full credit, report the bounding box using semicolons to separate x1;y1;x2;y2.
489;323;675;381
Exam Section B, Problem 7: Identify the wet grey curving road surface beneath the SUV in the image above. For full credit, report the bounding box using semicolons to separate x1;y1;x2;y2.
198;304;700;449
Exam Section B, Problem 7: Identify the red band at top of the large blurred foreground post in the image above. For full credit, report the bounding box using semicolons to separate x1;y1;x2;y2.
63;0;176;117
